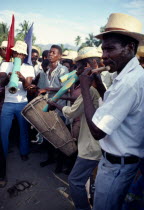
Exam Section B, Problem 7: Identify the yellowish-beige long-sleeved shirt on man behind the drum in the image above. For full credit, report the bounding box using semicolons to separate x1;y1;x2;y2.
62;87;101;160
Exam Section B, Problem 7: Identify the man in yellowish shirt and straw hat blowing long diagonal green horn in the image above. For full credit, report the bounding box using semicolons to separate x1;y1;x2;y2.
48;47;106;210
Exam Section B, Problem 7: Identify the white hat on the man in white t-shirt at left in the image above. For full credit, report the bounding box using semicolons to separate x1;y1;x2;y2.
11;41;27;55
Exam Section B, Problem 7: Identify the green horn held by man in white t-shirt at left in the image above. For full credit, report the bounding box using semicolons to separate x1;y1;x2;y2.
8;58;21;94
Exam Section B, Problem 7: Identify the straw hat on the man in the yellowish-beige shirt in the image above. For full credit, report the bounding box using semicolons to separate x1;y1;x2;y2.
75;47;102;61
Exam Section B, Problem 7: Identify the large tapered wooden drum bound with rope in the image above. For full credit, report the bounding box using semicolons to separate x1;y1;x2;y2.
21;95;77;156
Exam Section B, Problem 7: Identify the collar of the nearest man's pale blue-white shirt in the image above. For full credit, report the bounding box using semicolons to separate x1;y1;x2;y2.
114;57;139;81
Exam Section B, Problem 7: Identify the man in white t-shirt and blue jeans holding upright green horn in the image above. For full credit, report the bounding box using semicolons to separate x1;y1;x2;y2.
0;41;34;160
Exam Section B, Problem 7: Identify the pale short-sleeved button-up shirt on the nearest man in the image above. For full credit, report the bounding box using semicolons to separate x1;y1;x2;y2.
92;57;144;157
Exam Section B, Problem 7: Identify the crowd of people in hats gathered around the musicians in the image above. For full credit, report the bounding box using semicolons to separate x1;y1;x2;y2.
0;13;144;210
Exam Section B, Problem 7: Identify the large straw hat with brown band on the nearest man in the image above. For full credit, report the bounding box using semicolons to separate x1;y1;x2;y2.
96;13;144;43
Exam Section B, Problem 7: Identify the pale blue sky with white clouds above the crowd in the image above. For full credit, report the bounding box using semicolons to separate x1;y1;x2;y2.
0;0;144;45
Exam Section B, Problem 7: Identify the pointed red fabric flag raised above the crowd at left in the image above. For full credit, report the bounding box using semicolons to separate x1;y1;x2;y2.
6;15;15;62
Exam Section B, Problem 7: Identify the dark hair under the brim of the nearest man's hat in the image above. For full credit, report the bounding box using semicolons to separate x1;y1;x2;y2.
103;33;139;54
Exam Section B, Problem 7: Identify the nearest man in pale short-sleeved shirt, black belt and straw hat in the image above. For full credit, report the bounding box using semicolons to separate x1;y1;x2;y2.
80;13;144;210
